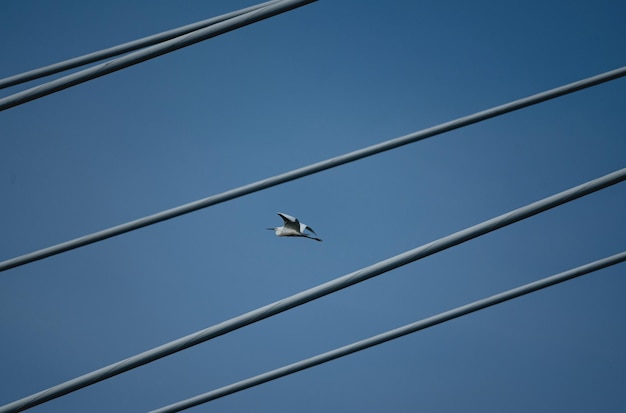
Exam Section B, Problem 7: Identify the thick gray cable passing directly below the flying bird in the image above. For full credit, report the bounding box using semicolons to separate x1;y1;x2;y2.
0;168;626;413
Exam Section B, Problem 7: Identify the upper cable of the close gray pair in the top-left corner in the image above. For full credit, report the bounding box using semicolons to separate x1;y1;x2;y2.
0;0;280;89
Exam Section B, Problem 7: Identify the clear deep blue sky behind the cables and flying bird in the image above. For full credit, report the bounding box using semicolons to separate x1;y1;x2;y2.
0;0;626;412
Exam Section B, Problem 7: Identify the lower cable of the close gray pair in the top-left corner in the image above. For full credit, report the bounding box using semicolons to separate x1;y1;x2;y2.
0;0;317;111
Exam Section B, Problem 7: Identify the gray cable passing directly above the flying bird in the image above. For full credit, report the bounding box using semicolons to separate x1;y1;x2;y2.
0;66;626;271
